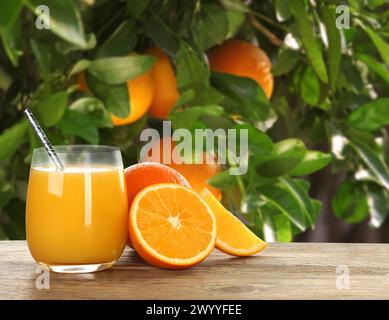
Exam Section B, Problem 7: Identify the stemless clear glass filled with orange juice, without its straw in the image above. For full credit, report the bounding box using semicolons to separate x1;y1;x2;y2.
26;145;128;273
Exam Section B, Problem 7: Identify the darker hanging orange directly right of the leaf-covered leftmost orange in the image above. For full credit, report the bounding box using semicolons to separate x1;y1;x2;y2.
145;47;179;119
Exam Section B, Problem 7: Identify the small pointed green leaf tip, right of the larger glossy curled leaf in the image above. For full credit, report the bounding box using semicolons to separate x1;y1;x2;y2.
290;150;332;176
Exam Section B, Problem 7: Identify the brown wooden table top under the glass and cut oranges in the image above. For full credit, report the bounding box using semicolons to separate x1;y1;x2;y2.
0;241;389;299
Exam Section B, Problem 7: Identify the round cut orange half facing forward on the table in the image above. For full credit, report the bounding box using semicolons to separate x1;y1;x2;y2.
129;183;216;269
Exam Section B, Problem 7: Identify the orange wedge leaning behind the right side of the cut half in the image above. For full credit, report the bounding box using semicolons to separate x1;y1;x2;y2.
201;188;267;256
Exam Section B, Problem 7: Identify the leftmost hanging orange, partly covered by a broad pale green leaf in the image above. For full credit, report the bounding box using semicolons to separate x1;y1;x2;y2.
76;53;154;126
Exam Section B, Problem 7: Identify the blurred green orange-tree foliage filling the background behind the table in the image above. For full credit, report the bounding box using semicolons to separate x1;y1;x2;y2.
0;0;389;241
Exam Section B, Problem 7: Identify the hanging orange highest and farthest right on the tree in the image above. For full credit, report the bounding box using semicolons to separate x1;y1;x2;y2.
208;39;273;98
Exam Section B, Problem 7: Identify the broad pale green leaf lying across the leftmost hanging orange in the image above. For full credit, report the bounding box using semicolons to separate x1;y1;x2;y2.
88;55;155;84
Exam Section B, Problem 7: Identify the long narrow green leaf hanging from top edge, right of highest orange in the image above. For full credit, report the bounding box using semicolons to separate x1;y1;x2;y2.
289;0;328;83
